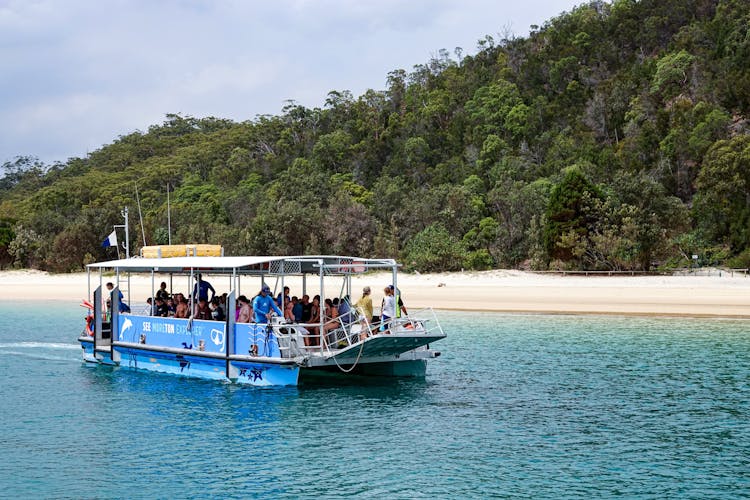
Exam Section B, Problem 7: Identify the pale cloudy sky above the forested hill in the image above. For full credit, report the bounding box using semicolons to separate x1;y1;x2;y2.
0;0;582;164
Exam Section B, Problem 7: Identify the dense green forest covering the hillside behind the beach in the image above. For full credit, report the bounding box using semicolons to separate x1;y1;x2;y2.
0;0;750;272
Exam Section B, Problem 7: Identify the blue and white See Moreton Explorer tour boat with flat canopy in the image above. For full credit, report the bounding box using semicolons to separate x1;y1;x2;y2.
78;255;446;386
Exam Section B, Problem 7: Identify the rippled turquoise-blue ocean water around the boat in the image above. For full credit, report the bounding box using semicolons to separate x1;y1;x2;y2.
0;302;750;498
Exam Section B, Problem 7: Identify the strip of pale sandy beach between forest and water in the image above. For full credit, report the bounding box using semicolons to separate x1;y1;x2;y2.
0;271;750;318
